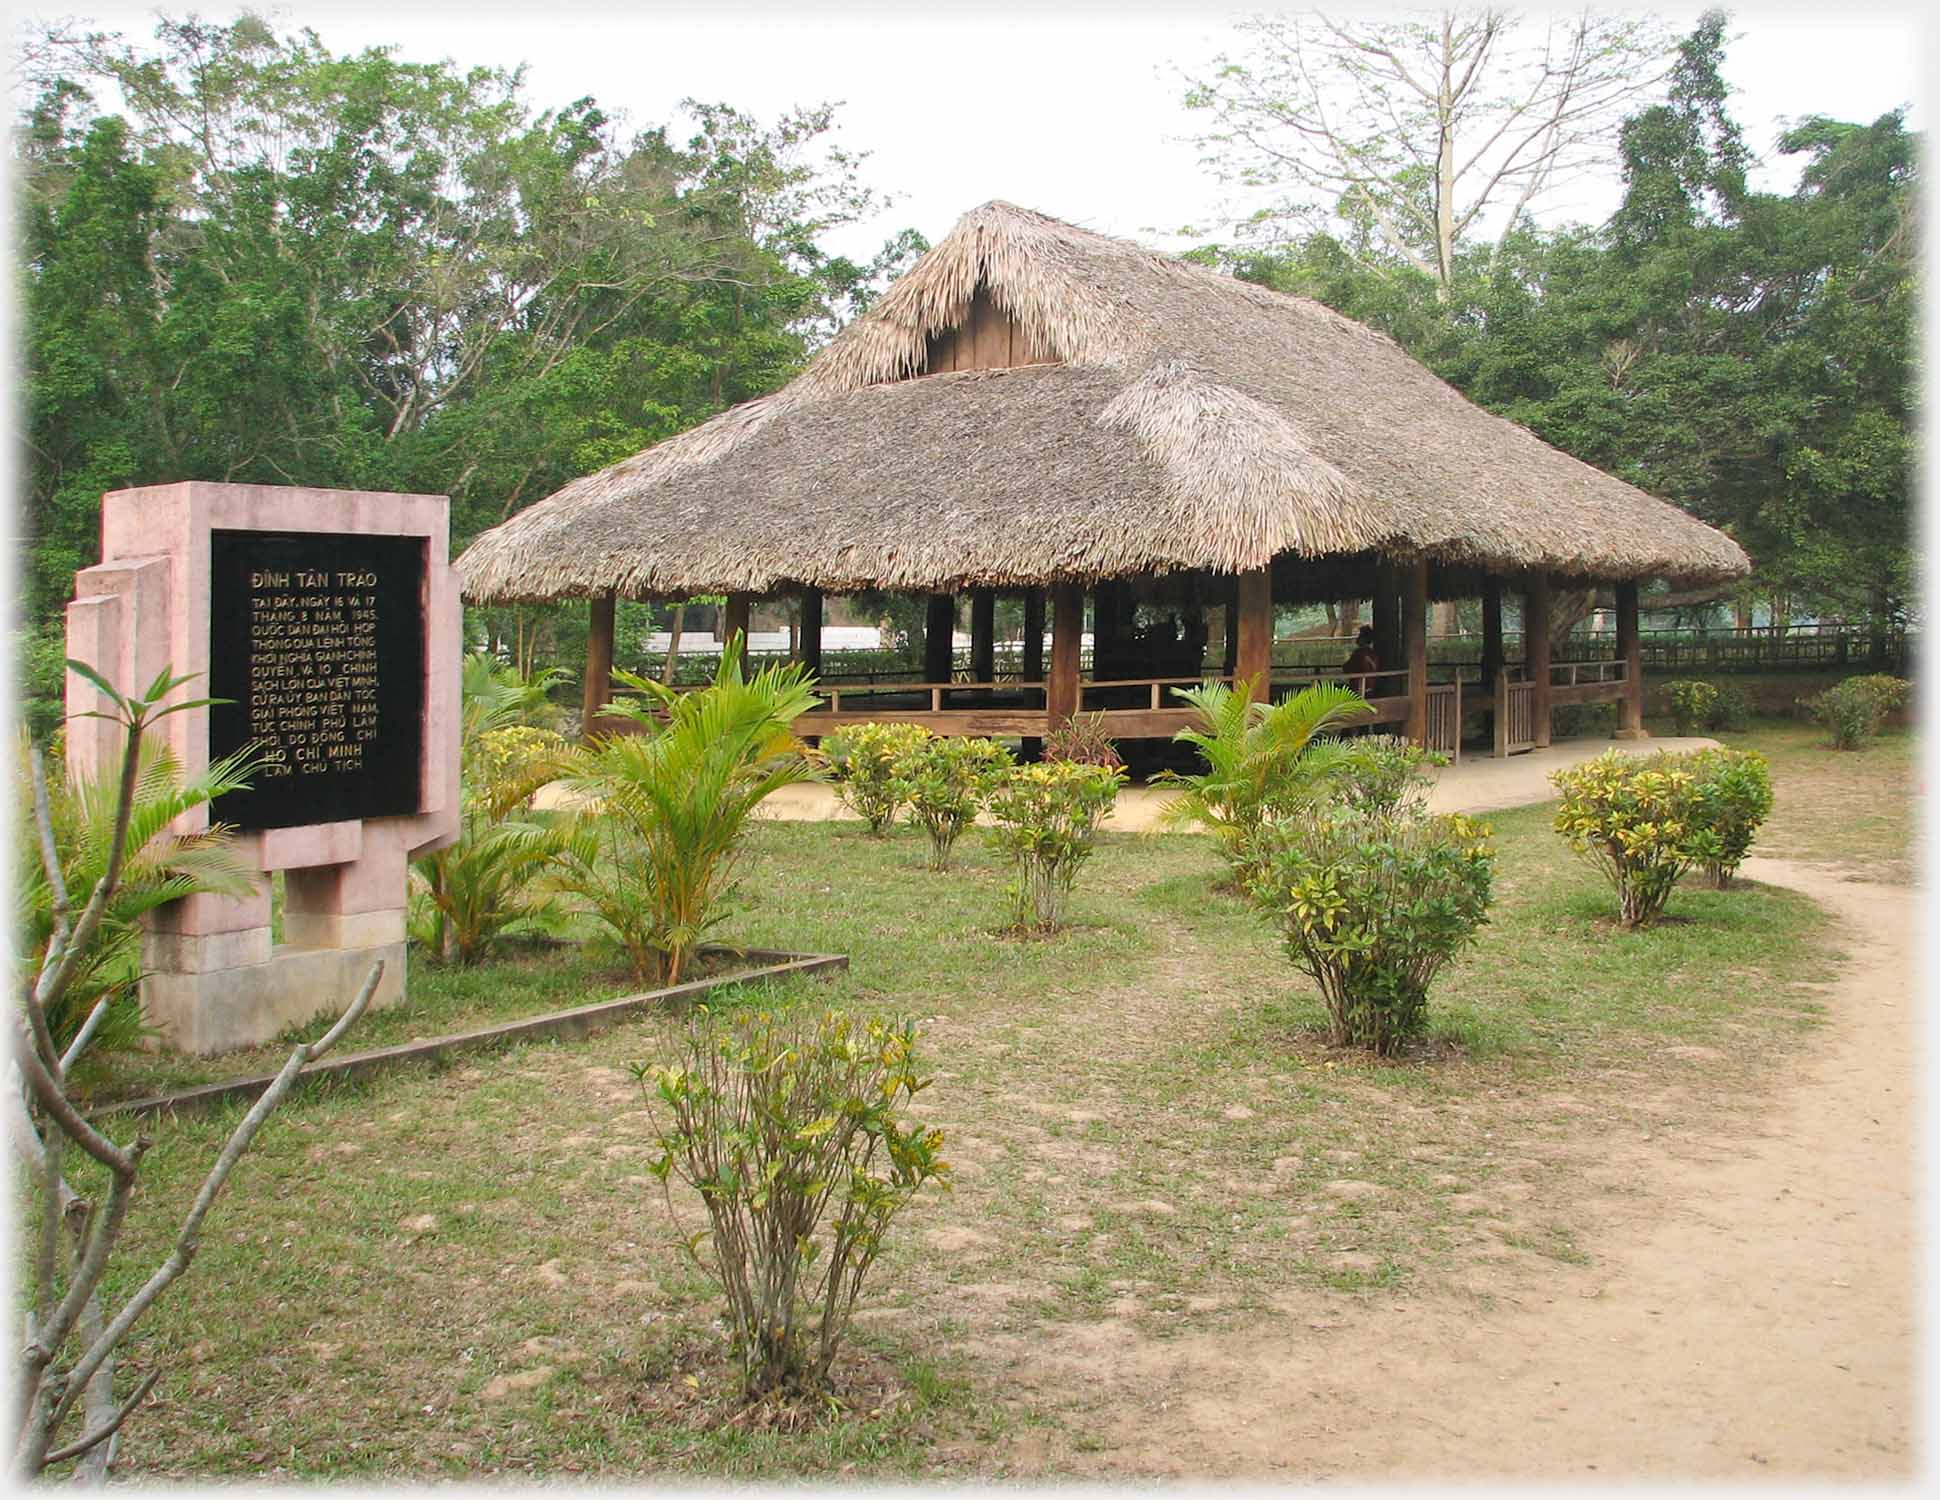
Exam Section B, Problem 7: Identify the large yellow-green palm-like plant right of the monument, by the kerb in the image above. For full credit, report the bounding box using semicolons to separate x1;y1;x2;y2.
561;636;815;984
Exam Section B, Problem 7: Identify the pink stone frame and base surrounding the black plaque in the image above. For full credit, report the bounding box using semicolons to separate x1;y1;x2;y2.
68;481;462;1052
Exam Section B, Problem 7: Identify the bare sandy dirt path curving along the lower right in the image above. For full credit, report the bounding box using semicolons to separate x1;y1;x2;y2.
1015;860;1919;1481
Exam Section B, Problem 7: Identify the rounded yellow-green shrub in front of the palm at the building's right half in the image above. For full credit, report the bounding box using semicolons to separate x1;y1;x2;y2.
1245;805;1494;1056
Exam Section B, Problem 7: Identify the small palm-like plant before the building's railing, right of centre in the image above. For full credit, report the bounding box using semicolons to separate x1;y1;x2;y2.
1156;681;1370;867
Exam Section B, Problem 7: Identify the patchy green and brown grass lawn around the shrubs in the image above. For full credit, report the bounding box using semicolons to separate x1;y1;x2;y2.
37;726;1913;1479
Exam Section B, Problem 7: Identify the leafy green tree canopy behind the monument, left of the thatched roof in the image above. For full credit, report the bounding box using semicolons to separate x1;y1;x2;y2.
16;16;922;619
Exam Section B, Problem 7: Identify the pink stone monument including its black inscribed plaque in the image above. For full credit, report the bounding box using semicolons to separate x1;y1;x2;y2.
68;481;462;1054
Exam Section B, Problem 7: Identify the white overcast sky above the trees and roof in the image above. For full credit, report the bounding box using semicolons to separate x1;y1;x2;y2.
19;0;1936;258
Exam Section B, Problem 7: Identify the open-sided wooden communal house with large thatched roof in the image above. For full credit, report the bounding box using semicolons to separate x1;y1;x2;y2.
458;204;1750;753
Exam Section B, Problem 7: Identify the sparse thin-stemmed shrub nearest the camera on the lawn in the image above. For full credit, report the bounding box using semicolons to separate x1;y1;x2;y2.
634;1011;949;1397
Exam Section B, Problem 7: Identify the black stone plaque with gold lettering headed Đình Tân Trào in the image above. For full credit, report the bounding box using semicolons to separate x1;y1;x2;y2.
210;532;425;829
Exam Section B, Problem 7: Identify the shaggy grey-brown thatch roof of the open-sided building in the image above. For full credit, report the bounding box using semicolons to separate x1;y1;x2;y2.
458;204;1750;602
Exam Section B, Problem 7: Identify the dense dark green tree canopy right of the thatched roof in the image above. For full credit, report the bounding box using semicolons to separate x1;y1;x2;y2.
1201;12;1921;619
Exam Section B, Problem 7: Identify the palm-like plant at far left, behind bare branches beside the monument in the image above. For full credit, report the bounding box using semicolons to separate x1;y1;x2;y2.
14;732;256;1052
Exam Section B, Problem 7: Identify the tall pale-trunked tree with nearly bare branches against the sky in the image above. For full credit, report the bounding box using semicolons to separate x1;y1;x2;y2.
1185;10;1666;299
